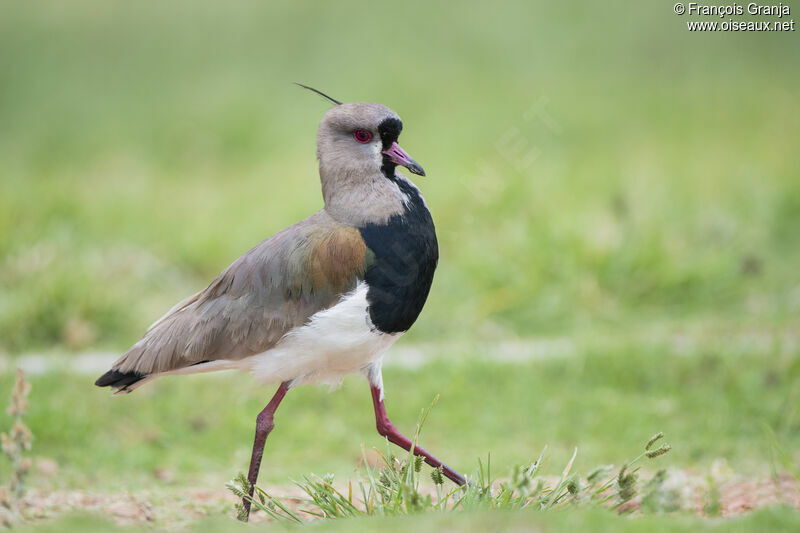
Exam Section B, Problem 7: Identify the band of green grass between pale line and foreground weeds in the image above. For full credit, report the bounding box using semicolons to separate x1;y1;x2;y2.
0;330;800;490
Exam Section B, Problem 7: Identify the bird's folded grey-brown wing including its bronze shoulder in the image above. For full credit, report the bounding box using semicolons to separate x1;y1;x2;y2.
97;211;367;378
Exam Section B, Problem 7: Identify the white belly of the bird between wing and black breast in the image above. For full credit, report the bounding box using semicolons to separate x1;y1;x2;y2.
237;283;402;385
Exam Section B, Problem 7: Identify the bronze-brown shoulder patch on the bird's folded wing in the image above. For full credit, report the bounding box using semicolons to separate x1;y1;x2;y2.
308;226;367;292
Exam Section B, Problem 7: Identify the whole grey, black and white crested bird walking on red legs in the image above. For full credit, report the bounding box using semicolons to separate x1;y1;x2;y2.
95;84;467;520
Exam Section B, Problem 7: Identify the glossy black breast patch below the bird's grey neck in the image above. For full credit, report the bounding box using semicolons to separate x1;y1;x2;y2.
359;179;439;333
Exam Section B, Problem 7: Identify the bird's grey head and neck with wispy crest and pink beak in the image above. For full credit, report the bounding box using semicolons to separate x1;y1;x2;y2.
302;86;425;223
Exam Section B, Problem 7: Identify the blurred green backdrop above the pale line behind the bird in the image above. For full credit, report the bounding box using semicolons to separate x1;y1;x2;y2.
0;2;800;352
